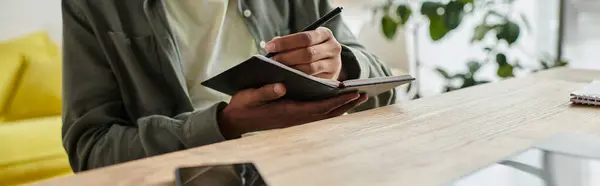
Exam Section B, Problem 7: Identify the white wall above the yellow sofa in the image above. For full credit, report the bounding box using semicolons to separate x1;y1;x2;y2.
0;0;62;44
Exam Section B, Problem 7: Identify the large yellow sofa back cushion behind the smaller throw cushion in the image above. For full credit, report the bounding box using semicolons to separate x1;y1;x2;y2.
0;32;62;121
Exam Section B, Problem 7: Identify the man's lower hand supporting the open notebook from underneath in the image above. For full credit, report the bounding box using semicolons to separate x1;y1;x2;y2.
218;84;367;139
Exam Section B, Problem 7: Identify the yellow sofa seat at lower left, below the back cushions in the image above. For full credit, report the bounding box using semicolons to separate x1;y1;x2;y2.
0;116;72;185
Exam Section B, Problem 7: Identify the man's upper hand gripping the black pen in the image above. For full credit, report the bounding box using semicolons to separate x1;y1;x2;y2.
265;27;346;80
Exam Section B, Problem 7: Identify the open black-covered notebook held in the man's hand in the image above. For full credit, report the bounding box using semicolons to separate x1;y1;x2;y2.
202;55;414;101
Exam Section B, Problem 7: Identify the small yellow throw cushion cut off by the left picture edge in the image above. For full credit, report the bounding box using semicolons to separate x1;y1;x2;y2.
0;53;24;117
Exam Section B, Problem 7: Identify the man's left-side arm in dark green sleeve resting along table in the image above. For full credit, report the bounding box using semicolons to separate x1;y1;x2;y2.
62;1;225;172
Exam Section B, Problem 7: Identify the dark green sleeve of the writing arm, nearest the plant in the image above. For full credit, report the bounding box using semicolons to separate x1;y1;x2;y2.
317;0;396;112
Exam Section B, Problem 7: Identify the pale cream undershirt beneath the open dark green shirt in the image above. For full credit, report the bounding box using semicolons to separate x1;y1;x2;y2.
163;0;257;110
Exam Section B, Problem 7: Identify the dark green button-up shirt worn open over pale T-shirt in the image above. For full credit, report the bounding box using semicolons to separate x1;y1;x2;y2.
62;0;395;172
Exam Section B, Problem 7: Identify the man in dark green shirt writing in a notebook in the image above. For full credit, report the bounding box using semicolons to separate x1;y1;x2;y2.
63;0;395;171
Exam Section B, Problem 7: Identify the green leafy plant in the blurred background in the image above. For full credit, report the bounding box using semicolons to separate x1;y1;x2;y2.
375;0;567;96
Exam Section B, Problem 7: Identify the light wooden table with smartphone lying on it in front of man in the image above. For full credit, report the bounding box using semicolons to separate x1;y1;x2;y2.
35;68;600;186
